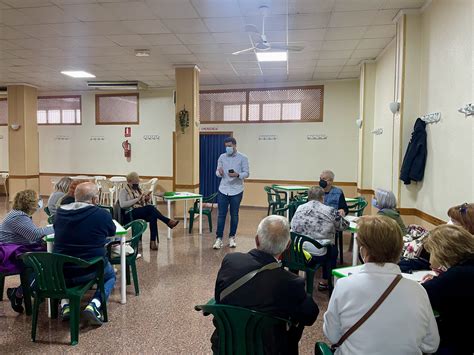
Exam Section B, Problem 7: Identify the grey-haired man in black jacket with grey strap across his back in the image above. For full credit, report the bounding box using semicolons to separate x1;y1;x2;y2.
211;216;319;354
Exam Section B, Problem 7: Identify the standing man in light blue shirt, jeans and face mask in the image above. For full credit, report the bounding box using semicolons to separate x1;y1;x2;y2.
213;137;249;249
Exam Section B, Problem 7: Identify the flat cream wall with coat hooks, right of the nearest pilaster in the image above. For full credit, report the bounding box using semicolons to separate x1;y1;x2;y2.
402;0;474;220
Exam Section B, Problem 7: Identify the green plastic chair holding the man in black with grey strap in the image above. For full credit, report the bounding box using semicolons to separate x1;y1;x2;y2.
194;299;291;355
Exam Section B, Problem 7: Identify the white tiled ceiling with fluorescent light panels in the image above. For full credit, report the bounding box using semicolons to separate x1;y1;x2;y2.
0;0;425;90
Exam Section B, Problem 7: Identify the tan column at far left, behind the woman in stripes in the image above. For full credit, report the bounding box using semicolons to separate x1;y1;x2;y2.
7;85;39;201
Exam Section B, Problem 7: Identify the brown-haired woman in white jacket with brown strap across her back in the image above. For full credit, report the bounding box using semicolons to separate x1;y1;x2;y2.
323;216;439;355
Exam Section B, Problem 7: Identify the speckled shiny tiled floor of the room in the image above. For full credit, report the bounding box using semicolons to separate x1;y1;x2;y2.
0;197;349;354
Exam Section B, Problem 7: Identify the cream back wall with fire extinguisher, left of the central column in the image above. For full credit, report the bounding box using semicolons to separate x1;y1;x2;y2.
38;90;174;186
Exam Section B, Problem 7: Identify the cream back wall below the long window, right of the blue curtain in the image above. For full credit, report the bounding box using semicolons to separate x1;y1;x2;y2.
201;80;359;182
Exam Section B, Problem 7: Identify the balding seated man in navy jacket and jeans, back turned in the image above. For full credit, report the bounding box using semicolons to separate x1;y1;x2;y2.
54;182;115;325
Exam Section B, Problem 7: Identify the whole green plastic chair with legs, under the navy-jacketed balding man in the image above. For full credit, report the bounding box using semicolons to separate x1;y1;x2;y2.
20;252;108;345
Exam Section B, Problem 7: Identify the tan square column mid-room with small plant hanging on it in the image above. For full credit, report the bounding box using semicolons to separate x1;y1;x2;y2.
173;65;199;216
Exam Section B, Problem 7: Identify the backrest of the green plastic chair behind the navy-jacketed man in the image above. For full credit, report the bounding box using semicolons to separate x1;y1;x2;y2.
20;252;103;298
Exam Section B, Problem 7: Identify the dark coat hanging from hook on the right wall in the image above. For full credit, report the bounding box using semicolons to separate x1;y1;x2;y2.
400;118;428;185
